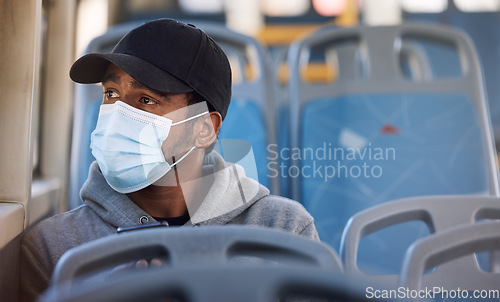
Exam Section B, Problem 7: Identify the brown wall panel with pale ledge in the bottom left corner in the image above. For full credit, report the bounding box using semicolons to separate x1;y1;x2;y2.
0;202;25;301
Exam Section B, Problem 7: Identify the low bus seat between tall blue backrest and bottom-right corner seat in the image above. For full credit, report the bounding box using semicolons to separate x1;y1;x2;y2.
340;195;500;288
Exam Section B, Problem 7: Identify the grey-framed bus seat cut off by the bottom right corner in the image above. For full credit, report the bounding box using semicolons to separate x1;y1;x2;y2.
400;220;500;292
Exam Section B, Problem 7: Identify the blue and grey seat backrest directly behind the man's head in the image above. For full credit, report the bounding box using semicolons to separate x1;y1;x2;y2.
69;22;278;208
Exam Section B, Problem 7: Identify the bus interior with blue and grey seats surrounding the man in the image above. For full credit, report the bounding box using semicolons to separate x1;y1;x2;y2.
0;0;500;302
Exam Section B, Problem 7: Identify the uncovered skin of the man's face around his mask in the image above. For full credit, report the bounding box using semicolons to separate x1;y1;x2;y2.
102;64;193;164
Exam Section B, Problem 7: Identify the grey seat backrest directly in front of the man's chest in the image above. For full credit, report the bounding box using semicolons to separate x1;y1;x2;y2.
51;225;343;285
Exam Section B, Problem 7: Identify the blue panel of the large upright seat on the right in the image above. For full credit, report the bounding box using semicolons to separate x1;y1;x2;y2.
296;93;489;273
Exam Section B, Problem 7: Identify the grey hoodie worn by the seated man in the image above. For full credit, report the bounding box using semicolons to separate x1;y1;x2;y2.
20;152;319;301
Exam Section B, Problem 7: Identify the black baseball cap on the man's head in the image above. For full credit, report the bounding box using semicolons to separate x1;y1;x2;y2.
70;19;231;119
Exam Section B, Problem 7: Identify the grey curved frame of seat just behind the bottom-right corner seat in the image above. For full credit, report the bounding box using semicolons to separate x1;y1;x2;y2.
340;195;500;287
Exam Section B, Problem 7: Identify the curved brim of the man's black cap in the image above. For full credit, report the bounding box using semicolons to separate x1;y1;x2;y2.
69;53;193;93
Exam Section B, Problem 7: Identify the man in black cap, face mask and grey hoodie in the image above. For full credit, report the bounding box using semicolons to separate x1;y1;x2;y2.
20;19;318;301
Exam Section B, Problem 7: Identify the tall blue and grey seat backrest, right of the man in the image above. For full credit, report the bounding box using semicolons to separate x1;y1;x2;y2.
286;24;499;254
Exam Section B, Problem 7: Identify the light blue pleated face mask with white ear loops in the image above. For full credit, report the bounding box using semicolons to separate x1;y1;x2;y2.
90;101;208;194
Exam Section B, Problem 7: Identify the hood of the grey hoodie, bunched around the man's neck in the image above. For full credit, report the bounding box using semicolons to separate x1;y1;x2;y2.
80;151;269;228
